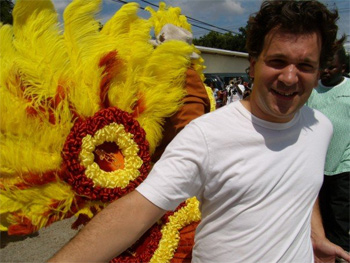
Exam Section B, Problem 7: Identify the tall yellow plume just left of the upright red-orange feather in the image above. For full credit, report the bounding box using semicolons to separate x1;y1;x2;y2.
63;0;104;116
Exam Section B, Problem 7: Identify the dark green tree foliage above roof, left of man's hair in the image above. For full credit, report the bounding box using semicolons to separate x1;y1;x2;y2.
193;27;247;52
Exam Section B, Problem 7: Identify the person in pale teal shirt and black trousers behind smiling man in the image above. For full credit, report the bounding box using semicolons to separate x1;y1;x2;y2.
307;48;350;254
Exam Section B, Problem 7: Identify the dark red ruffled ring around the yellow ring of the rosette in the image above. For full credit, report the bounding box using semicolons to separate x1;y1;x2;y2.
61;107;151;202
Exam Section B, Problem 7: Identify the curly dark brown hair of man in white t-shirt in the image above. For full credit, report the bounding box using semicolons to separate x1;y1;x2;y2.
246;0;345;68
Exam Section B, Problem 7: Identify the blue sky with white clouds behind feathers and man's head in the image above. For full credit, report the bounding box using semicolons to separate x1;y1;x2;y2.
52;0;350;52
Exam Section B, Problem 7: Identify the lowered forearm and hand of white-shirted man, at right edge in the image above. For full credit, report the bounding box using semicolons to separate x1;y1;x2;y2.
311;199;350;263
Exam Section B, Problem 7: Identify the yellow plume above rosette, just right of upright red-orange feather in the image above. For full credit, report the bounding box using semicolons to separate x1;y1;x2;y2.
101;3;153;112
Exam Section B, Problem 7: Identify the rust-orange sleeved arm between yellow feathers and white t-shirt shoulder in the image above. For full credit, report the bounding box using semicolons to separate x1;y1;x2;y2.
152;68;210;162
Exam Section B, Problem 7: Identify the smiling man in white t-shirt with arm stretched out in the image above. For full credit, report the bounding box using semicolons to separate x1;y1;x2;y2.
51;1;350;263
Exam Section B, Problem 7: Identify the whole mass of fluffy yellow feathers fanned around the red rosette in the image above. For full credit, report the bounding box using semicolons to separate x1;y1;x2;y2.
0;0;208;239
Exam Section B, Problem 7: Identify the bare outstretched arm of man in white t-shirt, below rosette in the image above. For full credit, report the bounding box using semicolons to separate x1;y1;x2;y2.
48;191;166;262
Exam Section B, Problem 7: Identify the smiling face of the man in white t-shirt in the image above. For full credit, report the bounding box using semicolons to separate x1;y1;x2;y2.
250;29;321;123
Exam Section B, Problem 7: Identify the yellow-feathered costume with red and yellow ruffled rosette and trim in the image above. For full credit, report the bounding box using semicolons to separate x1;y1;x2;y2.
0;0;216;262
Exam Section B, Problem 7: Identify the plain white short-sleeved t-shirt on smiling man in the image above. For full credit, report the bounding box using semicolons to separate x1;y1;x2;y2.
137;102;332;263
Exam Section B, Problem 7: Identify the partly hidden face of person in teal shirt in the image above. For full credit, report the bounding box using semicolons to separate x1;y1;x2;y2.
321;55;345;87
